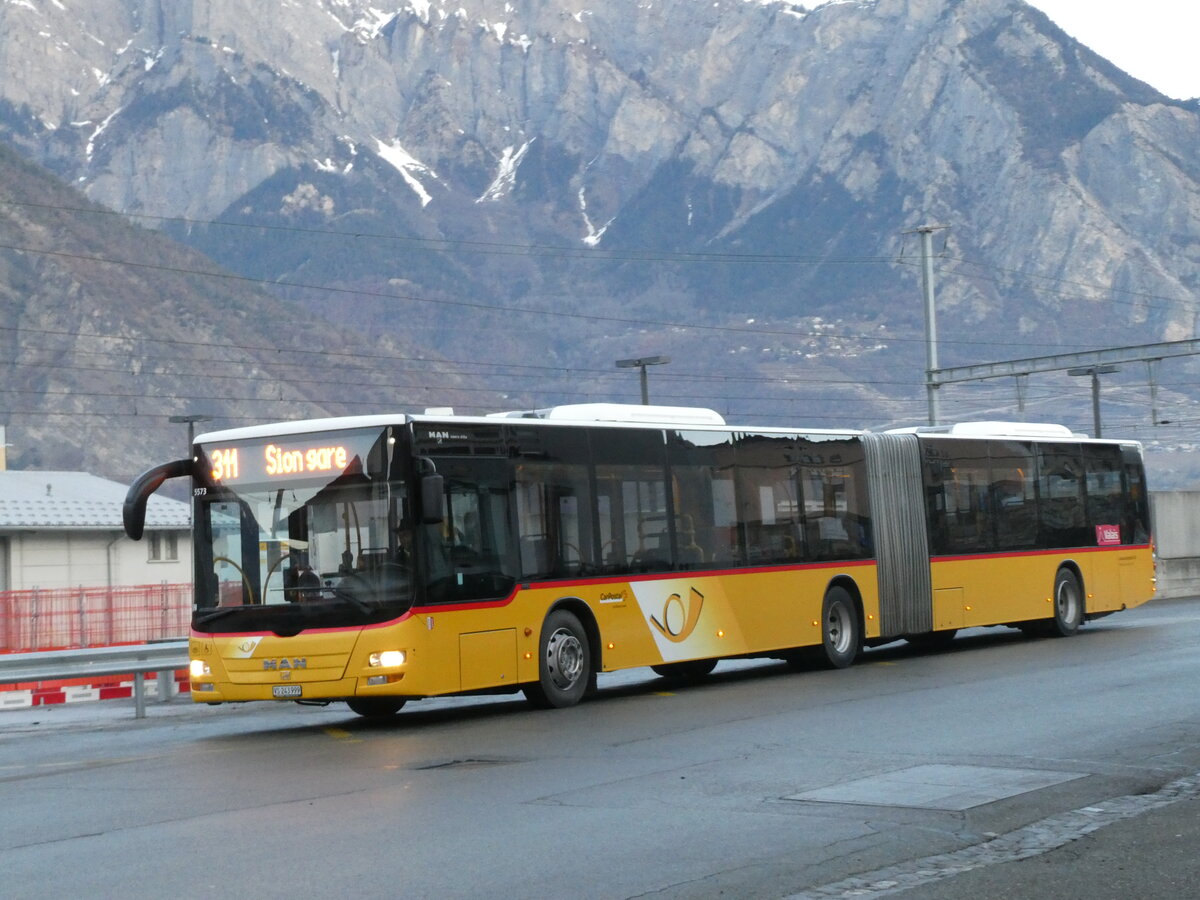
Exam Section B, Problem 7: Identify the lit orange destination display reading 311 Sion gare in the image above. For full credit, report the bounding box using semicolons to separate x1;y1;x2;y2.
202;431;379;485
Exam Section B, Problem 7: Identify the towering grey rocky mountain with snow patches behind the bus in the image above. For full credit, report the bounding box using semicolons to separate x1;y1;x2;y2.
0;0;1200;487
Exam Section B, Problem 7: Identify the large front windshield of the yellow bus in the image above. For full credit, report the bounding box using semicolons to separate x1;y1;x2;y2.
193;427;413;634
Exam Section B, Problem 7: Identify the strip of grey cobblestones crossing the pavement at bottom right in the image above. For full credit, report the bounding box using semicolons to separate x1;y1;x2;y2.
787;773;1200;900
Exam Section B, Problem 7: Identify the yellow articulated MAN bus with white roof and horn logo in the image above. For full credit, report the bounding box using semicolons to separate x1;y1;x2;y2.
125;404;1154;715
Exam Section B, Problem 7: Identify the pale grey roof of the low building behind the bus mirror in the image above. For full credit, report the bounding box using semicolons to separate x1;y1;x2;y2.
0;470;191;532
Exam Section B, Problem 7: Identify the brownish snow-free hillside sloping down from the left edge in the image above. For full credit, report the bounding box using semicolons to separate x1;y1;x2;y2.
0;145;477;480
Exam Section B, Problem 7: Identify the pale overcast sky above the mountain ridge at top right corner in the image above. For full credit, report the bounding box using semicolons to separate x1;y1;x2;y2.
1026;0;1200;100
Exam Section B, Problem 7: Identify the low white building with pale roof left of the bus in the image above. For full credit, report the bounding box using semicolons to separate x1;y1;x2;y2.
0;472;192;590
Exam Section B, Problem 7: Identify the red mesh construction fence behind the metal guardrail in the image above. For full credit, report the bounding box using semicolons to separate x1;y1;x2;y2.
0;583;192;653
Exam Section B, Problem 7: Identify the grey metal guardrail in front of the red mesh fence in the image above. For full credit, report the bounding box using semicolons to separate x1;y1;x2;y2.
0;641;188;719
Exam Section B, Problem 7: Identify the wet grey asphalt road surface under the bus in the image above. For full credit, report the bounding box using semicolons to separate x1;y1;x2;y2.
0;592;1200;900
